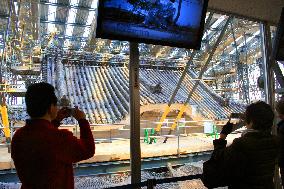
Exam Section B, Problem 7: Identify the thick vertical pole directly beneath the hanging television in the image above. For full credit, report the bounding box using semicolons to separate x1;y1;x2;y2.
129;42;141;184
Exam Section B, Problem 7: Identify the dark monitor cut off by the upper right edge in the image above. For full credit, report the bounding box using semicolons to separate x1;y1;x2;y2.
275;8;284;61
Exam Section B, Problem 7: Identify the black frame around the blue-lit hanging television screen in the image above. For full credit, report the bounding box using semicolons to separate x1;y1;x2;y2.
96;0;209;50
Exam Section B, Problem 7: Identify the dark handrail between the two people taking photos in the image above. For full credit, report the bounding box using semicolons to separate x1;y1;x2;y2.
107;174;202;189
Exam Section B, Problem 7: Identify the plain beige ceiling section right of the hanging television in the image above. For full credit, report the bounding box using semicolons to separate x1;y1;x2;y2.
208;0;284;25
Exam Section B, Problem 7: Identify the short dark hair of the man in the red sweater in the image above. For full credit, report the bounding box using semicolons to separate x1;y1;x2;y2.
25;82;57;118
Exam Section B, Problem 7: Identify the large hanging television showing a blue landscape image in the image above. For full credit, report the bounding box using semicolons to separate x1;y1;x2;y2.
96;0;208;49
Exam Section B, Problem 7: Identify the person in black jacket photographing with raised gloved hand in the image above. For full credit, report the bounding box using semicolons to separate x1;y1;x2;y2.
202;101;279;189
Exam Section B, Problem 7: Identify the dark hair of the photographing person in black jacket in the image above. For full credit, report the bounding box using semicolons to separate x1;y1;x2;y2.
245;101;274;131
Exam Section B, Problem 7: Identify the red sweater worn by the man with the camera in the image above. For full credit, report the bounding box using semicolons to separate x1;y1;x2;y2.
11;119;95;189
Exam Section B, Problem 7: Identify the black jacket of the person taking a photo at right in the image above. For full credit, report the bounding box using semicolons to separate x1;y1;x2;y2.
203;131;279;189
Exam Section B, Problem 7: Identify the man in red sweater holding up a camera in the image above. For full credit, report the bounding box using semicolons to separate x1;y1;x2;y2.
11;83;95;189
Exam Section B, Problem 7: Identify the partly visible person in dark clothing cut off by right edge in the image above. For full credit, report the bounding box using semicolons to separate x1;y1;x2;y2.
275;98;284;187
